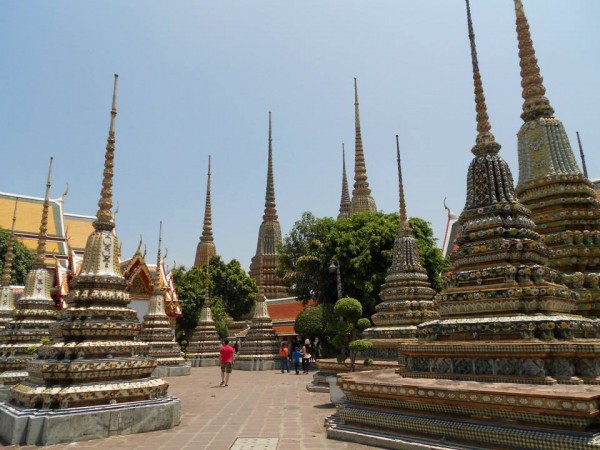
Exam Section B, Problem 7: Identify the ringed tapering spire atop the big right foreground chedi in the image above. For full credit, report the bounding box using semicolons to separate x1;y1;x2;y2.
465;0;500;155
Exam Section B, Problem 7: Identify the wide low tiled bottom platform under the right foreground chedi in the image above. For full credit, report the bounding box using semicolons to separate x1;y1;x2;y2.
326;370;600;450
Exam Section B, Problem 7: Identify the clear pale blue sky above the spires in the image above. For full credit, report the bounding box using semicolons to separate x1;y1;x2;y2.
0;0;600;268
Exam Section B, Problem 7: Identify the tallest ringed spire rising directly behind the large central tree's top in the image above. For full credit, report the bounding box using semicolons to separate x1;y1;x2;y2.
351;78;377;214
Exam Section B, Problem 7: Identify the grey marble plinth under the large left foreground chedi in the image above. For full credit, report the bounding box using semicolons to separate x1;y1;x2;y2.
0;397;181;445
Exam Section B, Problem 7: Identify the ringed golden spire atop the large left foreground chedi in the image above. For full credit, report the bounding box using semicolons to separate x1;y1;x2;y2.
94;74;119;230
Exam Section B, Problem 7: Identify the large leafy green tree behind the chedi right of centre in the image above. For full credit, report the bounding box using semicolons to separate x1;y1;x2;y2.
278;213;448;317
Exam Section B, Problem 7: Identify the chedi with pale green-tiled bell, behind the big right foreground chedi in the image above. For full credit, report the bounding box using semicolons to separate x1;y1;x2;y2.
516;0;600;316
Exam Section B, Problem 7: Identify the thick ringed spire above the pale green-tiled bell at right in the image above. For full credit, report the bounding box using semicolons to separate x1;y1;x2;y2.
514;0;554;121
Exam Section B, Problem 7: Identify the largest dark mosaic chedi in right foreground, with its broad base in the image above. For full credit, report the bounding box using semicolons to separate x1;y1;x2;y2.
327;0;600;450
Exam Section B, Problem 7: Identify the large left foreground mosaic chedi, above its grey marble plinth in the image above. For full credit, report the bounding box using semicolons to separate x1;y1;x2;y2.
11;75;168;409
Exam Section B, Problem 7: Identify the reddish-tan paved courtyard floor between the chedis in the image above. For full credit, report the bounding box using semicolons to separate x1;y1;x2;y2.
6;367;373;450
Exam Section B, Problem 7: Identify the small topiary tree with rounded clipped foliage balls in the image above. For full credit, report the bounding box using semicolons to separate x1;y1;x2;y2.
332;297;372;372
